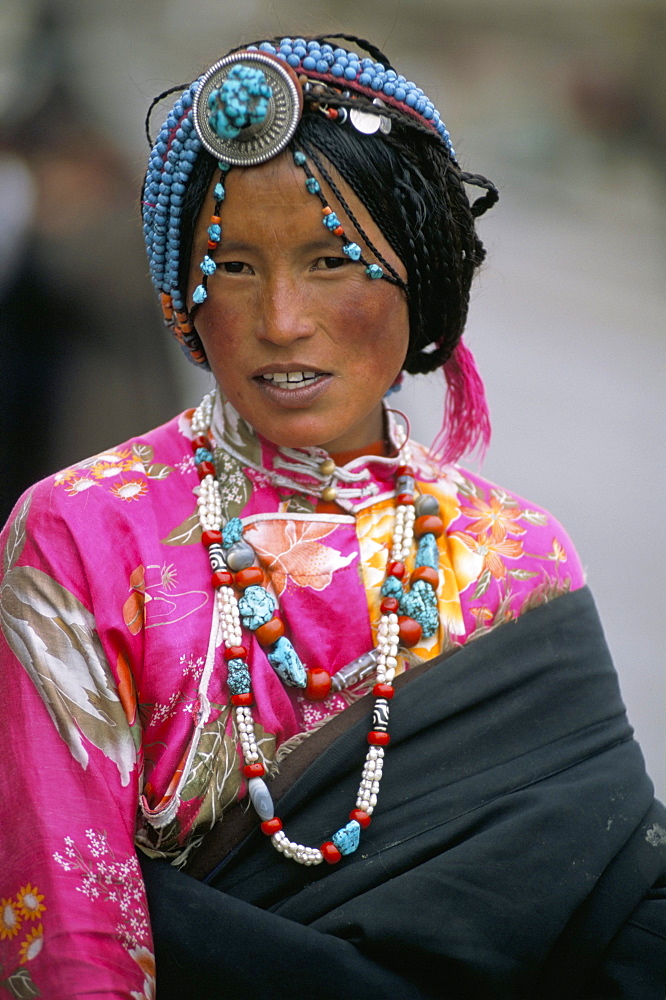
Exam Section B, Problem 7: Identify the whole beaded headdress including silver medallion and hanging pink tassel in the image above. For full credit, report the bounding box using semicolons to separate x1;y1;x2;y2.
143;36;497;460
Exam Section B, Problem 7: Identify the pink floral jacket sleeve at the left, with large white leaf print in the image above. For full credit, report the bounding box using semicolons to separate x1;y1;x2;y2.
0;488;155;1000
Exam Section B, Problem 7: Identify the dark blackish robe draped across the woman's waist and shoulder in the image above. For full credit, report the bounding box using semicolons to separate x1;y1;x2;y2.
137;589;666;1000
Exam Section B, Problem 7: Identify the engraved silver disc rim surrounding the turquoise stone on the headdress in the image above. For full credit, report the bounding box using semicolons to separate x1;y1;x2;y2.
192;51;303;167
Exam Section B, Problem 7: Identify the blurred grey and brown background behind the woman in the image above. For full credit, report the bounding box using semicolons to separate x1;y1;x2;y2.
0;0;666;797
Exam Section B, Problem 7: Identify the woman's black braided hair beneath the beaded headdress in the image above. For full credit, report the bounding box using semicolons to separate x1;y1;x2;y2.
174;34;499;374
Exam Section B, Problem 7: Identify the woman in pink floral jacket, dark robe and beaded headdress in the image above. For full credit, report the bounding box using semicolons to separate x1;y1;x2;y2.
0;31;666;1000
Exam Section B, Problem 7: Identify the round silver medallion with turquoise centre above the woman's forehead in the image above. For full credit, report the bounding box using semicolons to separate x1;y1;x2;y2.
192;51;303;167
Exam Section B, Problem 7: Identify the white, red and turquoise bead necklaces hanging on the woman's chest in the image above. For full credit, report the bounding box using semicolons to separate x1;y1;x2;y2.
192;394;439;865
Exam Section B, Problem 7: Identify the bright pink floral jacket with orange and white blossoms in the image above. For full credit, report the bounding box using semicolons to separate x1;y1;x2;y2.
0;402;583;1000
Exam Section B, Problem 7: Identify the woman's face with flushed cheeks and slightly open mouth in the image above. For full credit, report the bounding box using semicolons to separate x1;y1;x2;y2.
184;153;409;452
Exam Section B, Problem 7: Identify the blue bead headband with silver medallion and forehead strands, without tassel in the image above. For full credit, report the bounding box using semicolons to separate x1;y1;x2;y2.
143;38;455;366
